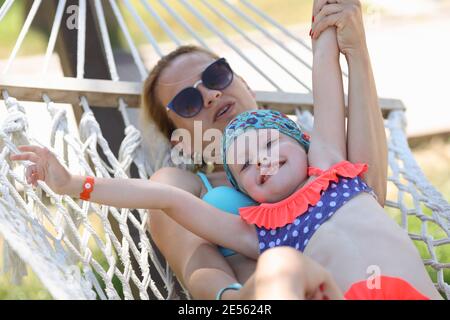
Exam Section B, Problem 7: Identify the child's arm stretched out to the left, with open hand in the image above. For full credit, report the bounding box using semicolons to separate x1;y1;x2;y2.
11;146;259;259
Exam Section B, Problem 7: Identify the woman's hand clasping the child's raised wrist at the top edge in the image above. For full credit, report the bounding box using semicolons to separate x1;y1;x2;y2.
311;0;367;57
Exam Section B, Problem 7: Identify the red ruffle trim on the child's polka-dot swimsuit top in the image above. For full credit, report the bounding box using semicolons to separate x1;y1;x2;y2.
239;161;368;229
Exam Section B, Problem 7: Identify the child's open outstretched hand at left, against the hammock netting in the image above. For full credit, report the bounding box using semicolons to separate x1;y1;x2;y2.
10;146;71;194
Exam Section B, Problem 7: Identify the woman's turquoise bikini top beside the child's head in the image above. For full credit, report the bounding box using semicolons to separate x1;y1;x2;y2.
197;172;257;257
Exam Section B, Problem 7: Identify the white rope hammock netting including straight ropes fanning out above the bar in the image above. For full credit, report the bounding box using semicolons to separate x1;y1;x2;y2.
0;0;450;299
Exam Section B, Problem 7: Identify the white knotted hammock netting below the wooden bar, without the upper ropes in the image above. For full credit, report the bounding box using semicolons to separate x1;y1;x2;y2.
0;90;450;299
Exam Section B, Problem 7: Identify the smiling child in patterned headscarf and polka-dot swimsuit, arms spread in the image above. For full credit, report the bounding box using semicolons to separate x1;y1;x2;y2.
11;29;440;299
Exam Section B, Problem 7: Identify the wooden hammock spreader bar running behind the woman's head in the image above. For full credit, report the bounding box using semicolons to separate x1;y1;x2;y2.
0;76;406;117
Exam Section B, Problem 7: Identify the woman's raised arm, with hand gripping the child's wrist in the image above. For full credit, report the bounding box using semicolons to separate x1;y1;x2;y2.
312;0;388;206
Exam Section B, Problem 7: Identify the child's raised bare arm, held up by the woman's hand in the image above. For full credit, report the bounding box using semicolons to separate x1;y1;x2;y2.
308;27;347;170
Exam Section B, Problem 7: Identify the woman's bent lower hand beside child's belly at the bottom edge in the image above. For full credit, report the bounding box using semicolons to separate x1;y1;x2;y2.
240;247;342;300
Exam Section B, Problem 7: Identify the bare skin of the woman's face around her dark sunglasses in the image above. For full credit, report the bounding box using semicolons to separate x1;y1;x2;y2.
156;52;258;154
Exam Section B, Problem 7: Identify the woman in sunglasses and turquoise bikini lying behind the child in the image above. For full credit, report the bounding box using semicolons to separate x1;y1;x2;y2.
143;0;428;299
